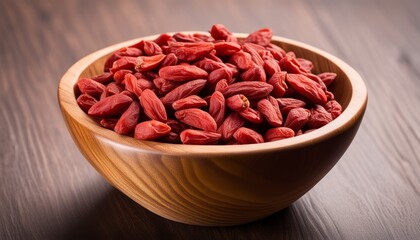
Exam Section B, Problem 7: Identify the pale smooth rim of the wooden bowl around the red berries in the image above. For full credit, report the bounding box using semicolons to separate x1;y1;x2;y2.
57;31;368;156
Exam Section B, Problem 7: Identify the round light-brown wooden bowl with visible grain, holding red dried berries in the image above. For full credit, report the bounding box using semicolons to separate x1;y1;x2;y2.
58;34;367;226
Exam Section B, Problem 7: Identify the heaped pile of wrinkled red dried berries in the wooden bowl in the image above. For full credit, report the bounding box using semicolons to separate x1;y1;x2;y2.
76;24;342;144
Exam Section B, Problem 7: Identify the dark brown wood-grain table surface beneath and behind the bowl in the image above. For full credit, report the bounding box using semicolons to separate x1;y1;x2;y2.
0;0;420;239
